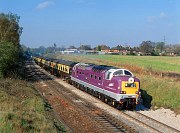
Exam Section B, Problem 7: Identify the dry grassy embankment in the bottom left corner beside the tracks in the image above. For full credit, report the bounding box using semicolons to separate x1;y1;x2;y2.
0;79;65;133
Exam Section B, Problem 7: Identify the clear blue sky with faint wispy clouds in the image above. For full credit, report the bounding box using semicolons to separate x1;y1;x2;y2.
0;0;180;47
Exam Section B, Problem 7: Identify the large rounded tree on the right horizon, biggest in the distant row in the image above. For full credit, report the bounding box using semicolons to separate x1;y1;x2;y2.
140;41;154;54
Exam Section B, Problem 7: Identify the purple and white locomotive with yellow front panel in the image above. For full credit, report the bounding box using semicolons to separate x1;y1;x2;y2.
71;63;140;108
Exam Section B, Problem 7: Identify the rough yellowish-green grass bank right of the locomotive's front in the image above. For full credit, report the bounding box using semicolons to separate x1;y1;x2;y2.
137;75;180;113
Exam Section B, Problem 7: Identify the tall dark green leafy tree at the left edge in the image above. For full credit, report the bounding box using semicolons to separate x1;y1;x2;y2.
0;13;22;78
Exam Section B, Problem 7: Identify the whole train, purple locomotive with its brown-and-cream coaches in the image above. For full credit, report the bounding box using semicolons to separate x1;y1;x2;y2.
33;56;140;109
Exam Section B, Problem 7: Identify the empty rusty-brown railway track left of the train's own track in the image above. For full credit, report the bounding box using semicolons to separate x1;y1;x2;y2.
47;78;137;133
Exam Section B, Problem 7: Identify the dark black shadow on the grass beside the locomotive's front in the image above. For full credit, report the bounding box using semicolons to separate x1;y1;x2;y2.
140;89;153;109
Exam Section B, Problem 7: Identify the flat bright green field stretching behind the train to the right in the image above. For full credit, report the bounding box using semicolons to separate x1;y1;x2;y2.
80;55;180;73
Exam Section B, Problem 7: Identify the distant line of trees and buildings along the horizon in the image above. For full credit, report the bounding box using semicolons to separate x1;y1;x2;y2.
26;41;180;56
